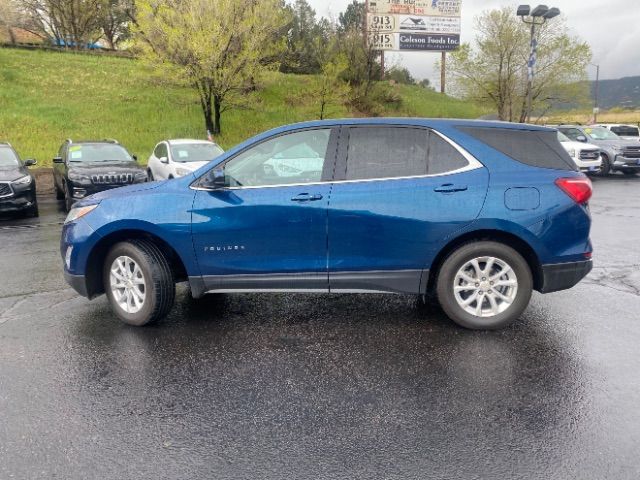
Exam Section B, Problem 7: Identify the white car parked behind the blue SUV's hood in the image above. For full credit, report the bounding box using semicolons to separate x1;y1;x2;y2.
147;139;224;180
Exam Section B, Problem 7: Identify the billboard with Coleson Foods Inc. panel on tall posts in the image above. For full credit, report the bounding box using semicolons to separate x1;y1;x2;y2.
367;0;462;51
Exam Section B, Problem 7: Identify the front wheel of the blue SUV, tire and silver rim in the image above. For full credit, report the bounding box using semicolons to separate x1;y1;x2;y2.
102;240;176;327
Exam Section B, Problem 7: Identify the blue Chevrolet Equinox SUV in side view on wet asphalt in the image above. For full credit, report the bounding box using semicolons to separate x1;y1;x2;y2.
61;119;592;329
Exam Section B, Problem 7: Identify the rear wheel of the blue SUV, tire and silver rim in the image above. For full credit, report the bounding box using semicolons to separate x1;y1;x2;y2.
436;241;533;330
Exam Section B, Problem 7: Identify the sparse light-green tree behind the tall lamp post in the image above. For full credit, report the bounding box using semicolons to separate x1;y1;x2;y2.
446;7;591;122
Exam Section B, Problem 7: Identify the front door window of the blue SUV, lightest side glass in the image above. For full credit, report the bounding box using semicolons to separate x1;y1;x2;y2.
224;128;331;187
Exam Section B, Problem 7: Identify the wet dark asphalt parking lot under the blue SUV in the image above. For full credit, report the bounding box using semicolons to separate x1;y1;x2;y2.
0;175;640;480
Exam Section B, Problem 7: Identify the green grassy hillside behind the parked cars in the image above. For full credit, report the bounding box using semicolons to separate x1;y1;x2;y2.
0;48;481;165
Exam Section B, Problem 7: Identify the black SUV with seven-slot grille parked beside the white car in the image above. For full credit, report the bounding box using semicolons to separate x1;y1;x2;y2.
53;140;147;211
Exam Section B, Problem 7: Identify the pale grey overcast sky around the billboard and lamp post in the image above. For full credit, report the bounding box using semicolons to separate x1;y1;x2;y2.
307;0;640;85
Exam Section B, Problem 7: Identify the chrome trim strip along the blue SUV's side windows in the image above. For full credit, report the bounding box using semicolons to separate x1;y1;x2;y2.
189;125;484;192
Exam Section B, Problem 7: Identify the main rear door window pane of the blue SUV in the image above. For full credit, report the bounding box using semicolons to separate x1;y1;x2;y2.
346;127;429;180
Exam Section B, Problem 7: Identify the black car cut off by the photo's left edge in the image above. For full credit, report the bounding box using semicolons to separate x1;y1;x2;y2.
0;143;38;217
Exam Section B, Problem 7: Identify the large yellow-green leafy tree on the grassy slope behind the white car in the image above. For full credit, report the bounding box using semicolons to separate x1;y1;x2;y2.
136;0;289;134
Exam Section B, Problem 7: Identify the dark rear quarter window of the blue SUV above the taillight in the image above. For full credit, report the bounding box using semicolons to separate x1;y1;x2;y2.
459;127;577;170
